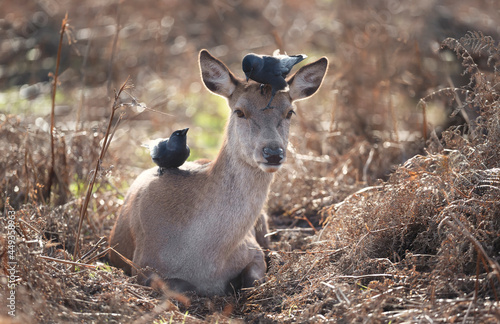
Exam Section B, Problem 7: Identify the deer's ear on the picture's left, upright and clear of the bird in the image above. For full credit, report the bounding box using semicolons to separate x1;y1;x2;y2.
199;50;238;98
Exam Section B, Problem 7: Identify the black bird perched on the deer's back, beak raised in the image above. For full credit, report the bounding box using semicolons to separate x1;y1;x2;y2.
145;128;191;175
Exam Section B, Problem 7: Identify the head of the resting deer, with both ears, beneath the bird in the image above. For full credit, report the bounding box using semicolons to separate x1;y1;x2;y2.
199;50;328;173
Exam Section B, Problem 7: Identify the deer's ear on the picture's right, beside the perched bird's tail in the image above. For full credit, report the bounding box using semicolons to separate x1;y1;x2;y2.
288;57;328;101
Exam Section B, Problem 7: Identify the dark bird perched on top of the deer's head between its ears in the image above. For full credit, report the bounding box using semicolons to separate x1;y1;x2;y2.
242;50;307;110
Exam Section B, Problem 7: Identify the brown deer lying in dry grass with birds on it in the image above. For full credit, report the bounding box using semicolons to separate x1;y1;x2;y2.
110;50;328;295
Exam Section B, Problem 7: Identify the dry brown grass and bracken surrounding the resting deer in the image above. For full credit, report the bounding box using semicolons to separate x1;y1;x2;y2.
0;1;500;323
